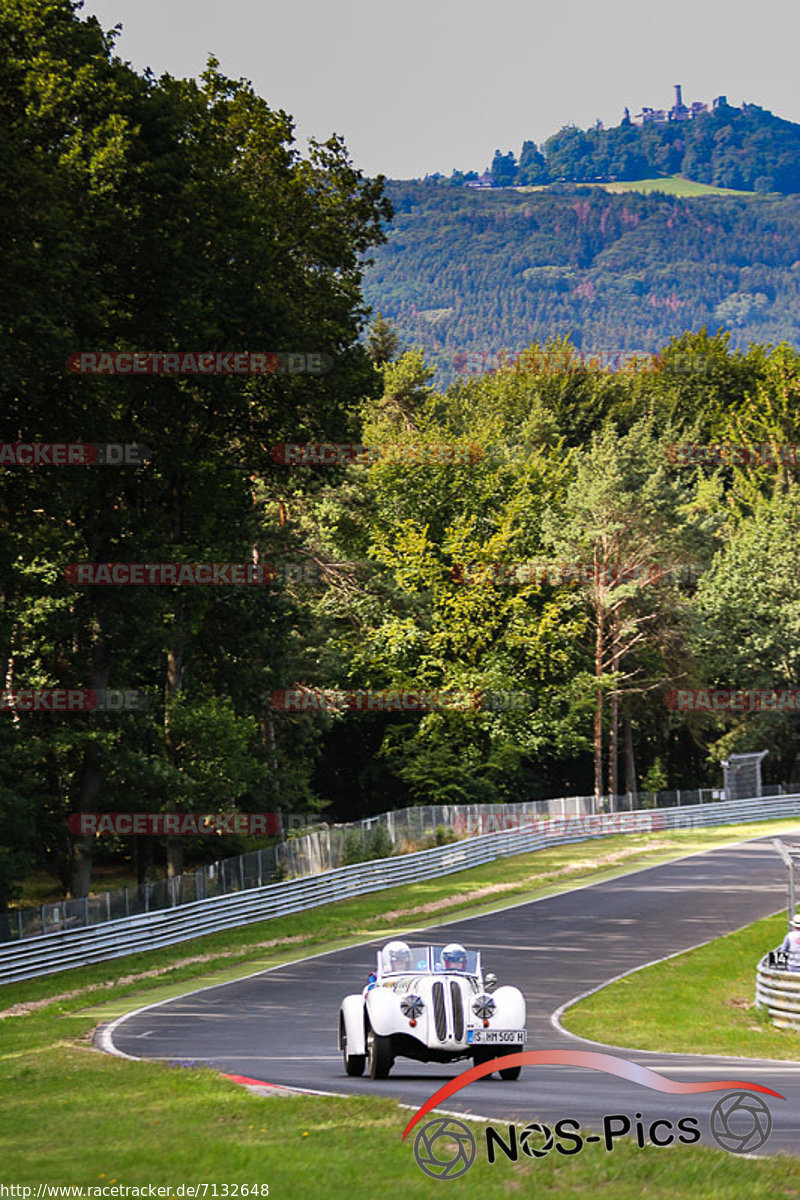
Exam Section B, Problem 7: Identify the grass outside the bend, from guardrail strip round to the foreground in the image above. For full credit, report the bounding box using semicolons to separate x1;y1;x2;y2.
0;821;800;1200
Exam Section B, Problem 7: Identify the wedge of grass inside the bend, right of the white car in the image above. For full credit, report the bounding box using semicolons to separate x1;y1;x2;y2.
561;914;800;1061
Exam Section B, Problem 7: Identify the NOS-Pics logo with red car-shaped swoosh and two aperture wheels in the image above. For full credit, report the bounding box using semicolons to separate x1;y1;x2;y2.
403;1050;784;1180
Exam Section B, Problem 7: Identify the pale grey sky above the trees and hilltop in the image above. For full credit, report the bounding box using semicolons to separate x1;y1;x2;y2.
83;0;800;179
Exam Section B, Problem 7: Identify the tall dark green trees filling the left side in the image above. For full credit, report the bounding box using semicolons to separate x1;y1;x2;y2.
0;0;390;895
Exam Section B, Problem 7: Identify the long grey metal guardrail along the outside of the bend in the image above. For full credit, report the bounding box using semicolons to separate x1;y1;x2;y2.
0;794;800;984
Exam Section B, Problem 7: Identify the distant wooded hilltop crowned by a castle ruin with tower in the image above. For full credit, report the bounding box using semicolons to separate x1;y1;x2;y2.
441;84;800;194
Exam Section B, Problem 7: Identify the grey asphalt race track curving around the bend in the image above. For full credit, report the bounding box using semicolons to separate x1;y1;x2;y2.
101;839;800;1153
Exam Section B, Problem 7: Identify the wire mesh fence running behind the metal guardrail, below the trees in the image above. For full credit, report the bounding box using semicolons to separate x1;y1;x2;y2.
0;784;790;942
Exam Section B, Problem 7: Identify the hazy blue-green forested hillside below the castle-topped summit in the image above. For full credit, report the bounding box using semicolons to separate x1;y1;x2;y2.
365;182;800;384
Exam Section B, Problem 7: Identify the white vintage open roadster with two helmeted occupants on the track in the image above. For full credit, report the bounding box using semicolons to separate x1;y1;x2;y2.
339;942;528;1079
